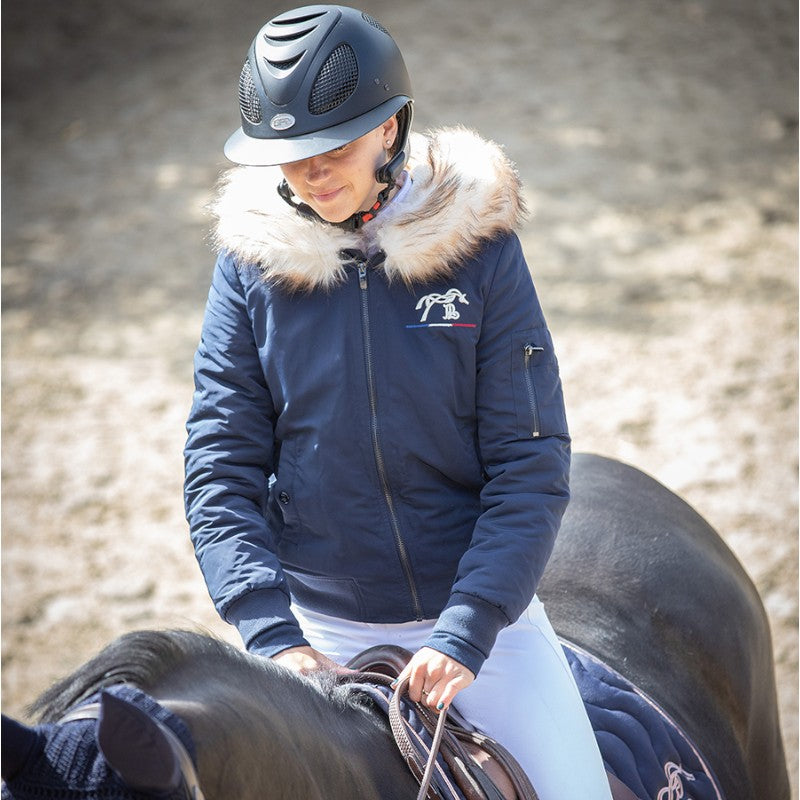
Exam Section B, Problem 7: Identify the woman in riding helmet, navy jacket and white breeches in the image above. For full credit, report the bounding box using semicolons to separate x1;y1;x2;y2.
186;6;610;800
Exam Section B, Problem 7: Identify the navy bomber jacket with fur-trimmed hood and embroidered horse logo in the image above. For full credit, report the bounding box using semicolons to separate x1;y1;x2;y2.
185;129;570;673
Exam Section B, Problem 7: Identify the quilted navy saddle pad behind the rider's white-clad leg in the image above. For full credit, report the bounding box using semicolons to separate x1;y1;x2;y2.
561;639;724;800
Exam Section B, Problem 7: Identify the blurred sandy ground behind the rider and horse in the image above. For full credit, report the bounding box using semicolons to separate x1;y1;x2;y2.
2;0;798;797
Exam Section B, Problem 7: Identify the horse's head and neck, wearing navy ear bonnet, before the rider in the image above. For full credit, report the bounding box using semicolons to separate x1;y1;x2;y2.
2;631;416;800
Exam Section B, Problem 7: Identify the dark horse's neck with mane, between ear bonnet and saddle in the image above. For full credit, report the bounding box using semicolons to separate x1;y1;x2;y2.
29;630;410;798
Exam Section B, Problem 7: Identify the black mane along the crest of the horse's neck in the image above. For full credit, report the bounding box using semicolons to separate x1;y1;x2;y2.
28;630;370;722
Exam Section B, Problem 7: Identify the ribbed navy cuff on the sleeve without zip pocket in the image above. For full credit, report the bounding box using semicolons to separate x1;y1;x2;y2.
225;589;308;658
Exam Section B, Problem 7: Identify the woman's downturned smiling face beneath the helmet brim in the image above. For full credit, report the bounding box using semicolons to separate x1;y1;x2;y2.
281;117;397;222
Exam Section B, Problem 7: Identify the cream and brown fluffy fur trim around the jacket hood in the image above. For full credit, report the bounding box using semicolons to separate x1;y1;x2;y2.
210;123;525;290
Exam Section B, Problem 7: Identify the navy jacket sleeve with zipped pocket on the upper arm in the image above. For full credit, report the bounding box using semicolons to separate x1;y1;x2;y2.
426;235;570;673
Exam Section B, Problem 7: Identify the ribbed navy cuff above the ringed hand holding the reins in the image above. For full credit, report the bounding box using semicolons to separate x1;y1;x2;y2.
425;592;509;675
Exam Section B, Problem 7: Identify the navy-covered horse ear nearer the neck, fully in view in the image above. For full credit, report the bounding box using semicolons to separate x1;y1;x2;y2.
96;692;181;792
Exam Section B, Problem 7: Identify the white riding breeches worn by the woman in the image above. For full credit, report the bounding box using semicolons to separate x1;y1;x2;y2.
292;597;611;800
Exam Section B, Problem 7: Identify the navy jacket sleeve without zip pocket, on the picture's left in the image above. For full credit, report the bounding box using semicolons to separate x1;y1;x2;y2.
184;255;307;655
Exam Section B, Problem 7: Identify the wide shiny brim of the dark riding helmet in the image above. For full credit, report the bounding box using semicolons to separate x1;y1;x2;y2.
224;95;411;167
